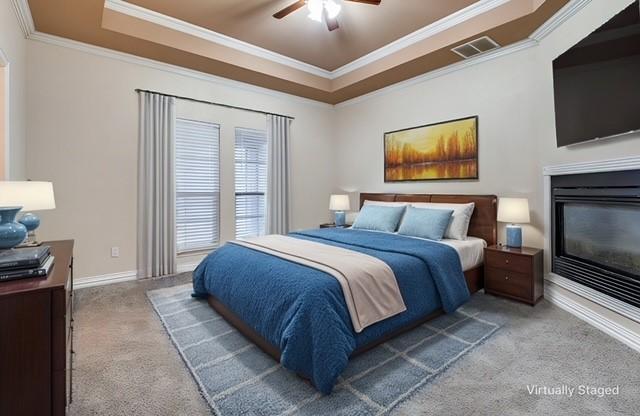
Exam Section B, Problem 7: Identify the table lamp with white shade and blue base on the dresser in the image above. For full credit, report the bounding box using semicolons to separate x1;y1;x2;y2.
0;181;56;246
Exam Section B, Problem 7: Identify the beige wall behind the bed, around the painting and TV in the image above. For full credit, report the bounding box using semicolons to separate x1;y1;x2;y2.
335;0;640;247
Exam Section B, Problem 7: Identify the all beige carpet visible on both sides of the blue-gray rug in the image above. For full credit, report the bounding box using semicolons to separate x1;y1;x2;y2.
71;274;640;416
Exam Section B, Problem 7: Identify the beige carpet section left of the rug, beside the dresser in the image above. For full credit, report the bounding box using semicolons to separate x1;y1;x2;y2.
70;274;211;416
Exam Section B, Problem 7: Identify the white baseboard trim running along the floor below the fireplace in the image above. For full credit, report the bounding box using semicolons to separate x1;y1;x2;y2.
544;284;640;352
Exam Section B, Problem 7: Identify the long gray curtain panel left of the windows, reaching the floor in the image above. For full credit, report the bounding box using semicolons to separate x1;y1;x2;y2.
138;92;176;278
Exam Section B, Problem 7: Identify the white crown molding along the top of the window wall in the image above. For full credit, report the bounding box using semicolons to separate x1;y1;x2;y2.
29;32;333;112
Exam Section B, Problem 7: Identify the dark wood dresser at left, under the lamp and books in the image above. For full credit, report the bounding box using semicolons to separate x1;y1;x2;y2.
0;240;73;416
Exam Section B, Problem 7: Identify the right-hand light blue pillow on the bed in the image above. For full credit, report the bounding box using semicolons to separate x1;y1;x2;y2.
398;207;453;240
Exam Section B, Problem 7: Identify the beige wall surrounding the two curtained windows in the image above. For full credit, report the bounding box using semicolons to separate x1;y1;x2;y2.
27;41;333;278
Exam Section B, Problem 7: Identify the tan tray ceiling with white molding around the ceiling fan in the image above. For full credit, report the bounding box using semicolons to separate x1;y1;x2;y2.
28;0;568;104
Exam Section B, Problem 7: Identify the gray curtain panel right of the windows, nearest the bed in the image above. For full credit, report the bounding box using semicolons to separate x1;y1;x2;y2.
266;115;291;234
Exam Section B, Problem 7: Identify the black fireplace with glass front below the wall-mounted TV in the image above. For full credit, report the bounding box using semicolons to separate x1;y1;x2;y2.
551;170;640;307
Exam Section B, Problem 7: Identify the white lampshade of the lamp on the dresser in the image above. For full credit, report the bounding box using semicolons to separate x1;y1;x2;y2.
0;181;56;211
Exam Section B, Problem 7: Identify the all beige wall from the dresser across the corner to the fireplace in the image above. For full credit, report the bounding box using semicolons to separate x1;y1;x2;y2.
20;0;638;286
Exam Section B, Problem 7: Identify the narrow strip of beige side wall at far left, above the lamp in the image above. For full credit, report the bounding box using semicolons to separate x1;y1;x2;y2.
0;0;27;179
